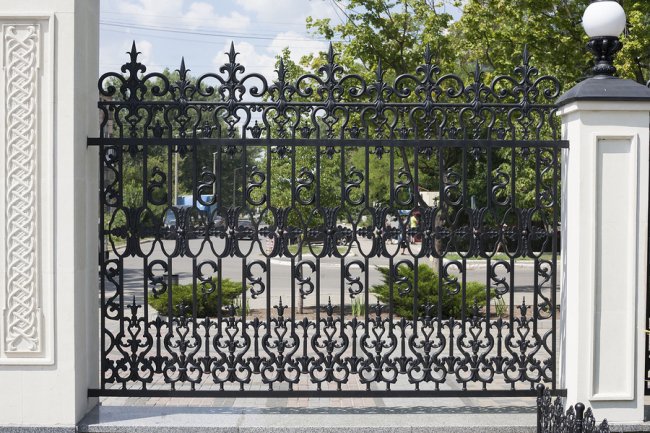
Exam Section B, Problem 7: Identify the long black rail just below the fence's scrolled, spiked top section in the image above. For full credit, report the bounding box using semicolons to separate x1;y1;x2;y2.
88;137;569;149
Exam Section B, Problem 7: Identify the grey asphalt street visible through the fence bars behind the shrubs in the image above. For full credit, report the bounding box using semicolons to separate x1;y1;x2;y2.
111;239;560;308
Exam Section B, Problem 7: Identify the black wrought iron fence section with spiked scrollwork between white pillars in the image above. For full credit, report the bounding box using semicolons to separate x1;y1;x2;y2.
89;44;567;397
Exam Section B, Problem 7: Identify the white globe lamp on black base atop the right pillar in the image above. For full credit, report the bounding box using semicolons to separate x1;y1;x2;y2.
582;0;626;78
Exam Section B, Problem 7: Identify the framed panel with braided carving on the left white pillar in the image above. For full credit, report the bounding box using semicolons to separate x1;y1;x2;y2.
0;15;52;365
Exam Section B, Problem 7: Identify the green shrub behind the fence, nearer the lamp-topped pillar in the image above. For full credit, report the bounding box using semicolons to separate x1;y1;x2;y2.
370;264;486;319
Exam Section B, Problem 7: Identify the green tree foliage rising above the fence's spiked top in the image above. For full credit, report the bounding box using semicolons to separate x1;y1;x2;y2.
304;0;650;86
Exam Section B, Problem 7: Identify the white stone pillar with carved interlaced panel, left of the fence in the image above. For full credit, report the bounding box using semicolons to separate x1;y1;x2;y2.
0;0;100;431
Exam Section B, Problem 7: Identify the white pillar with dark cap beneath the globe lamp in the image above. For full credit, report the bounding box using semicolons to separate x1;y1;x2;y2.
558;78;650;422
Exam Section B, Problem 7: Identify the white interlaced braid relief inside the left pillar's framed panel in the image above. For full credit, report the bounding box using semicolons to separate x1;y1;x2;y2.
2;24;42;354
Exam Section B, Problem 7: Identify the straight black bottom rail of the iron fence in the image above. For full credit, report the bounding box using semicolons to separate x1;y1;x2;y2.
88;389;566;398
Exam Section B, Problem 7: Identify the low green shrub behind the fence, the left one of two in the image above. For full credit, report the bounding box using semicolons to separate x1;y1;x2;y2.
149;278;248;317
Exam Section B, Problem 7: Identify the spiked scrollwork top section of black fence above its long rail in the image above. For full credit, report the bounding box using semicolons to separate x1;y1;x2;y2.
99;43;560;141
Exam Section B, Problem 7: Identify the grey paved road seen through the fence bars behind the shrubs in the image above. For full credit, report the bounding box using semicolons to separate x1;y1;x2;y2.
112;236;560;308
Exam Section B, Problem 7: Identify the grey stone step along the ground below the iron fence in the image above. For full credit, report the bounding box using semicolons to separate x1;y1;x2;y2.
78;406;536;433
